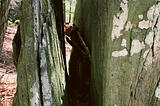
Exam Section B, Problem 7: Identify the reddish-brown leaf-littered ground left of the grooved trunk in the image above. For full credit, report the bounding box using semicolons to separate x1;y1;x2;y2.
0;26;17;106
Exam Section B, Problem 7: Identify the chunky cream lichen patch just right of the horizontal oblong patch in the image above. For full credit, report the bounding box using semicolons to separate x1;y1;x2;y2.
131;40;145;56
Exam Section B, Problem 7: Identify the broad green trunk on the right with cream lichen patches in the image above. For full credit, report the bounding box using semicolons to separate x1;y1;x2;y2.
74;0;160;106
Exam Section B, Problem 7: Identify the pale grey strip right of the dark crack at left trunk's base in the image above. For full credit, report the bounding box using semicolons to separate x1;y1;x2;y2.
41;70;52;106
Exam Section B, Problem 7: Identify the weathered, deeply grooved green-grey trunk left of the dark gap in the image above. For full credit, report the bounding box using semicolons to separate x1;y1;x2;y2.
13;0;68;106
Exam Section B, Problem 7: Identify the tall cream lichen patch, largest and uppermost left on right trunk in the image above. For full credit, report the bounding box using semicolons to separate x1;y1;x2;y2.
111;0;128;40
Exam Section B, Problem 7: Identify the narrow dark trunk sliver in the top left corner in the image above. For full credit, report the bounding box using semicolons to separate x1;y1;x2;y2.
0;0;11;54
